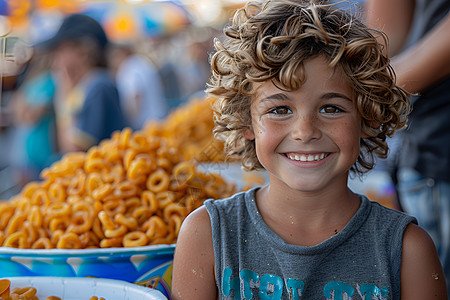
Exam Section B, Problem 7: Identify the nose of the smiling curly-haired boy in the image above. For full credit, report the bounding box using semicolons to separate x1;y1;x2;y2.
291;114;322;143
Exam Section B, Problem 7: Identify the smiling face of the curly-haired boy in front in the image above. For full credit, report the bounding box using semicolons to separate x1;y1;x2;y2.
244;56;361;191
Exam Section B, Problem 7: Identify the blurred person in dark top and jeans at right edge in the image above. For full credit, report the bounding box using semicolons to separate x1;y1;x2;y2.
366;0;450;292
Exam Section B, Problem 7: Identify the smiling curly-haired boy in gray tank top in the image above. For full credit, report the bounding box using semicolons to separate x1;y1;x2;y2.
172;0;447;300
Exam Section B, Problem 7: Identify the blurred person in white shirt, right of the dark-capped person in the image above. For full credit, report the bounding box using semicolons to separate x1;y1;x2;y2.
108;43;169;130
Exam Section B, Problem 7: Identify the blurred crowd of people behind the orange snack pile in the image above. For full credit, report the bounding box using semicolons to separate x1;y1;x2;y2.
0;14;217;199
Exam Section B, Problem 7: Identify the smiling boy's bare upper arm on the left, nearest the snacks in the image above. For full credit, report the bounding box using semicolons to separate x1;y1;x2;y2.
171;206;217;300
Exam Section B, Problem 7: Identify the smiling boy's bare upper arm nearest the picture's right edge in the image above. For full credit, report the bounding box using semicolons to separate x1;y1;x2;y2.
401;224;447;300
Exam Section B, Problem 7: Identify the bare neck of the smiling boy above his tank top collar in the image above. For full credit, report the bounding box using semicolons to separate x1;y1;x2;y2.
256;178;360;246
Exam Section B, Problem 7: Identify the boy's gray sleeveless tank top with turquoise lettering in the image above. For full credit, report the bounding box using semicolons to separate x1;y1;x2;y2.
205;188;417;300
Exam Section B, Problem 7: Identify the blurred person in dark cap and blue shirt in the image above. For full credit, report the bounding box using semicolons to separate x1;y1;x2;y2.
37;14;129;153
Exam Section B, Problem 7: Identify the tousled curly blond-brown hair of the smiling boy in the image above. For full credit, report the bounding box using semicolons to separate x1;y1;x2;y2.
207;0;410;174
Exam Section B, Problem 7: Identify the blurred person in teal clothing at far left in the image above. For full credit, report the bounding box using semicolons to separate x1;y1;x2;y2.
9;51;56;186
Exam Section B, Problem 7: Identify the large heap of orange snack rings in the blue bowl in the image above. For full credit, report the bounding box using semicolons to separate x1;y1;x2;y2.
0;99;236;249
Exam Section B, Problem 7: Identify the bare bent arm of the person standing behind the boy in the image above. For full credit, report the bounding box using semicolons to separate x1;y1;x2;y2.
366;0;450;93
